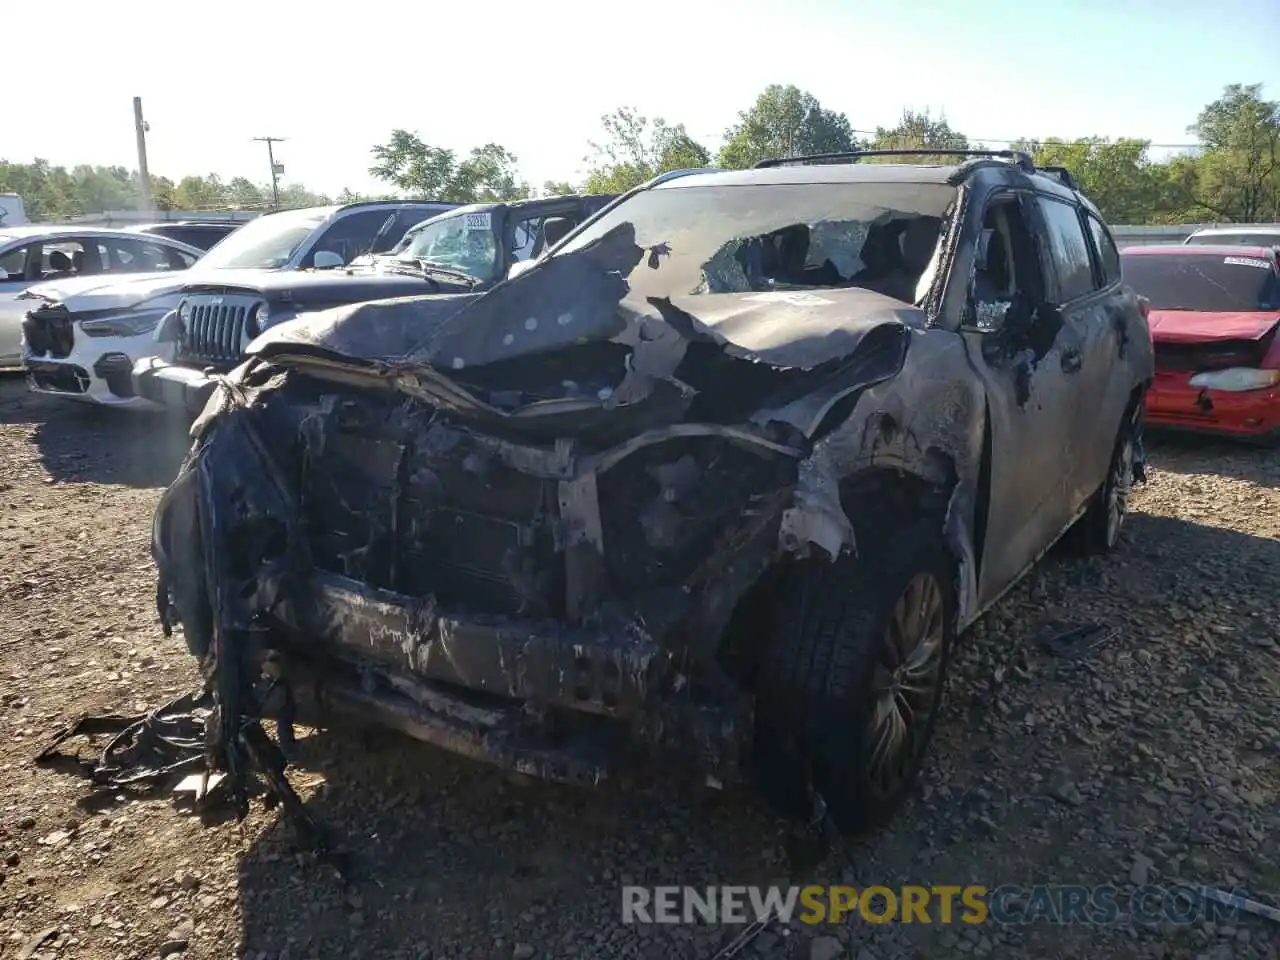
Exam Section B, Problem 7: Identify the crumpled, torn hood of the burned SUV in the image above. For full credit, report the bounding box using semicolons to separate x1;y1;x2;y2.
255;224;924;435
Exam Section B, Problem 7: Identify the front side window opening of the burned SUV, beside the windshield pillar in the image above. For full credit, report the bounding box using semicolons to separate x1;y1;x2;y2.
969;196;1044;330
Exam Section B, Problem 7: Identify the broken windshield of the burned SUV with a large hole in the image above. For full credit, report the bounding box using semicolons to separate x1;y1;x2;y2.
545;183;956;303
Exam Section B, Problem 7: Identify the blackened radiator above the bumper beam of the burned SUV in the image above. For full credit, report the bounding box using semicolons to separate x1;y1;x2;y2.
298;396;564;617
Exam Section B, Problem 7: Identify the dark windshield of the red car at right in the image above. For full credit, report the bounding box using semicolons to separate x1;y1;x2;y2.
1121;252;1280;312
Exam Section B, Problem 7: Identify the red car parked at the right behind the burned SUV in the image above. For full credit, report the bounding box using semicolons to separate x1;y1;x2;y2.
1120;244;1280;440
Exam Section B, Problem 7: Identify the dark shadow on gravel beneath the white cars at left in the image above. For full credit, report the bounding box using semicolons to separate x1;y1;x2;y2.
0;376;191;486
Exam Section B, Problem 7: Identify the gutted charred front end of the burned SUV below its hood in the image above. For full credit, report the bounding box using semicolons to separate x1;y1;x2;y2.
170;370;797;781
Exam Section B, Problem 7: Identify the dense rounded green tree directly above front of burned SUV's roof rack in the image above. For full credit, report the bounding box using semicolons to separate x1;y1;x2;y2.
718;83;856;169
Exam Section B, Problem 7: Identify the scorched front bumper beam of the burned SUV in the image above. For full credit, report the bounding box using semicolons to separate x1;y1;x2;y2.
276;571;742;785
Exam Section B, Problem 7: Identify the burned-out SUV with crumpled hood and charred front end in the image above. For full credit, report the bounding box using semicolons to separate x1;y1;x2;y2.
154;151;1152;831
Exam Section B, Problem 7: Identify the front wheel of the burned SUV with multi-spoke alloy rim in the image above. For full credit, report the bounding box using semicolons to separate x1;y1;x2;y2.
756;520;955;833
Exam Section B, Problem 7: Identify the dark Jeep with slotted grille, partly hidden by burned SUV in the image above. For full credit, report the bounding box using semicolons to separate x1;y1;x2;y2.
133;196;612;413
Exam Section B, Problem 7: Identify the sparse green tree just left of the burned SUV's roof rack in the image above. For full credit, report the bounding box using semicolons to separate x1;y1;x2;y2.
584;106;712;193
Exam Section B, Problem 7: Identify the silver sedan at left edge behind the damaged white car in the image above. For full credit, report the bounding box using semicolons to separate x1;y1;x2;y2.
0;225;204;370
